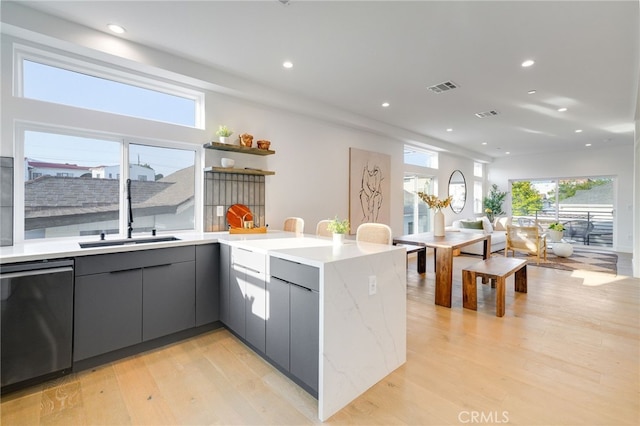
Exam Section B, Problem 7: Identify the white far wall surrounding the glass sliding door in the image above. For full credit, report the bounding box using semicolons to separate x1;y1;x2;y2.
487;146;634;253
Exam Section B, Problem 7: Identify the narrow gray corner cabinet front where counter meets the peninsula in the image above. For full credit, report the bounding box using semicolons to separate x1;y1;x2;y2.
196;244;220;327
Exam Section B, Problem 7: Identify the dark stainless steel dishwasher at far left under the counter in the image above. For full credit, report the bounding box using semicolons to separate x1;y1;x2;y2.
0;259;74;394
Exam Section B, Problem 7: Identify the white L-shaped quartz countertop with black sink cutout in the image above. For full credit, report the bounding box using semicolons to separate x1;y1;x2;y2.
0;230;404;266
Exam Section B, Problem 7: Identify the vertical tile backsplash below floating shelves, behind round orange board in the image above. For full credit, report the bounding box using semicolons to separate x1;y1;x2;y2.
204;172;265;232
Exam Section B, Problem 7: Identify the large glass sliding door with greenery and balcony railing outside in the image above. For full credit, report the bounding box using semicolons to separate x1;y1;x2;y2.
511;177;615;247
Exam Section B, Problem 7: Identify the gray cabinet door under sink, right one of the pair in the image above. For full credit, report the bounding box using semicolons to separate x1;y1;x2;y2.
142;262;196;341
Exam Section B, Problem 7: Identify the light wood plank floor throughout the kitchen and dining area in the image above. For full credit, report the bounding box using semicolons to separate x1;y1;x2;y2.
1;256;640;425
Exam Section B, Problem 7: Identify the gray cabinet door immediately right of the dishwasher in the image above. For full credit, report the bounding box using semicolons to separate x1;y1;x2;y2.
73;269;142;361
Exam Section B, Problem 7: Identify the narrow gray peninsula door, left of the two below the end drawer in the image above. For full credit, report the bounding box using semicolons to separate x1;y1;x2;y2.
265;277;290;371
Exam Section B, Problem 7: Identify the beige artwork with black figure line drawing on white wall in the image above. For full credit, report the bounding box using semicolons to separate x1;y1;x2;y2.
349;148;391;234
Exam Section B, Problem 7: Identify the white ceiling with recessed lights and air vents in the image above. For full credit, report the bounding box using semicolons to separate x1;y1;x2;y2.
6;0;640;157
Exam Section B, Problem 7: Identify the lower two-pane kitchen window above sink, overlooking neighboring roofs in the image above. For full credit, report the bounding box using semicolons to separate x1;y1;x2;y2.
21;128;198;240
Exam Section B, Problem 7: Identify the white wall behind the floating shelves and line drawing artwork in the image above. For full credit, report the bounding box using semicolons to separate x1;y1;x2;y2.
205;94;403;233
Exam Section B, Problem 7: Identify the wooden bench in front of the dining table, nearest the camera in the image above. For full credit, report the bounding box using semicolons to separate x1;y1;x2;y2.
462;256;527;317
